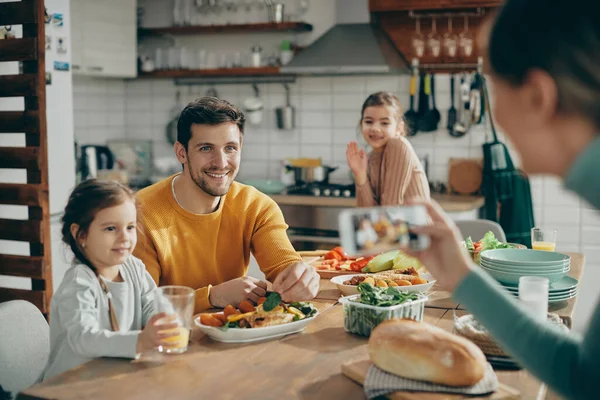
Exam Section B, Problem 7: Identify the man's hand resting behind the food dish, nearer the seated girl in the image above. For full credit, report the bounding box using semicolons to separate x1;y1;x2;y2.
208;276;267;308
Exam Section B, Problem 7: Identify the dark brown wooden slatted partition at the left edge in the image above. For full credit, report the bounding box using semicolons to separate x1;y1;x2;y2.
0;0;52;314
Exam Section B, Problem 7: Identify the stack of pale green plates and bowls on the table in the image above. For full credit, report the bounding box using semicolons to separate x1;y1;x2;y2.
480;249;578;303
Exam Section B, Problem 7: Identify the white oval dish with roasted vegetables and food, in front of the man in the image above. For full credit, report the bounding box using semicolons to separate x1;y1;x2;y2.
194;292;319;343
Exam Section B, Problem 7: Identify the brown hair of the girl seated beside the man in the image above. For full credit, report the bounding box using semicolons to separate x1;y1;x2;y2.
62;179;137;272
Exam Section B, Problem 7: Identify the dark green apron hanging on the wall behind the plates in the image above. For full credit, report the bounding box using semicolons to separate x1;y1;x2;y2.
481;79;535;247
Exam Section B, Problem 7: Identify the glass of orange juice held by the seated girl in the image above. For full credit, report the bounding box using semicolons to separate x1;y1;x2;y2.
156;286;194;353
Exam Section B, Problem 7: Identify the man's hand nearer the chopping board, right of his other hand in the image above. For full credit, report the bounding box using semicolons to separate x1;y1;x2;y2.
273;262;320;303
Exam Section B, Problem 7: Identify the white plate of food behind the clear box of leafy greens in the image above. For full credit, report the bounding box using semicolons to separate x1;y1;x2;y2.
330;269;436;296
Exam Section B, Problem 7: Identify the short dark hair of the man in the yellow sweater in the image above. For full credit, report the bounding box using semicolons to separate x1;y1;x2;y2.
177;97;246;150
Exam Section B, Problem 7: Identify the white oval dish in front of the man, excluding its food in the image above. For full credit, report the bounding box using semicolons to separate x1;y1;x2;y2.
194;311;319;343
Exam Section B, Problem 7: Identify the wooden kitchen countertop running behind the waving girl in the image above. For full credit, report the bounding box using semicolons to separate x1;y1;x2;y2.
270;193;484;212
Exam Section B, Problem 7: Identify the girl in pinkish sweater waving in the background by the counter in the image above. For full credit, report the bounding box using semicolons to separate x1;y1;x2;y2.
346;92;429;207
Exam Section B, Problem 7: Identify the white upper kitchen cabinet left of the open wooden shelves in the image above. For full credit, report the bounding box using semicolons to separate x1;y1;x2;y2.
71;0;137;78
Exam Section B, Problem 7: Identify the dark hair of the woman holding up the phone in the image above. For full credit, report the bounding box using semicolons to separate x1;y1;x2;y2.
488;0;600;127
